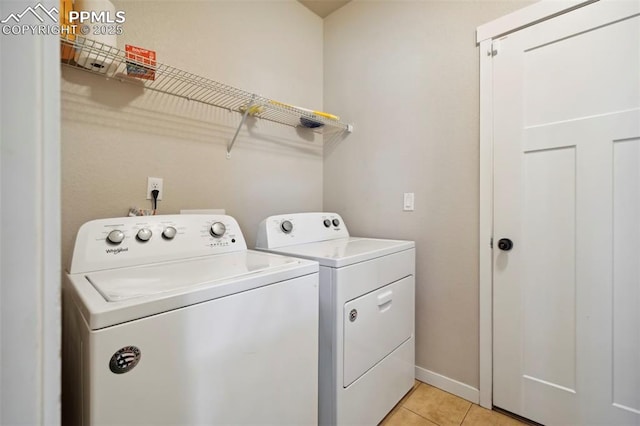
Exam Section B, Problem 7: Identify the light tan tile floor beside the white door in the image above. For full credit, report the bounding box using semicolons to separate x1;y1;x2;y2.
380;380;526;426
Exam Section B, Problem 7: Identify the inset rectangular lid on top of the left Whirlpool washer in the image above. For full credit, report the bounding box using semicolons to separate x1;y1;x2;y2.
86;252;298;302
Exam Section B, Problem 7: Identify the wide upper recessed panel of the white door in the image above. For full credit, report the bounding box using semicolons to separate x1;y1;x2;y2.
524;10;640;127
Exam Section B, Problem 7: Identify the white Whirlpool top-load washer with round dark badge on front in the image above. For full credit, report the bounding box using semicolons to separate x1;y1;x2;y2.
62;215;318;425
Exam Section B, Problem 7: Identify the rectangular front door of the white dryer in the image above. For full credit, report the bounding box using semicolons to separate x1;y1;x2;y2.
343;275;414;388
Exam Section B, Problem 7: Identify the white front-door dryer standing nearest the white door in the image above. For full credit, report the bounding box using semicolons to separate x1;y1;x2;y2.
256;213;415;425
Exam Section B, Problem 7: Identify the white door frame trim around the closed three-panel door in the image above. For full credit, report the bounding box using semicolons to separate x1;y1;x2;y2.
476;0;605;409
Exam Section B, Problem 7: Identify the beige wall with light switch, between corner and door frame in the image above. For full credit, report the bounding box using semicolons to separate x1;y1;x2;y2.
324;0;531;392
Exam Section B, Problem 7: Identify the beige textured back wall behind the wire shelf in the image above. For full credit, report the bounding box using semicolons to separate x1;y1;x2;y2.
62;0;323;268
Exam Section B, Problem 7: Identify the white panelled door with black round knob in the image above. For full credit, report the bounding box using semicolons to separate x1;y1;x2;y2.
493;0;640;425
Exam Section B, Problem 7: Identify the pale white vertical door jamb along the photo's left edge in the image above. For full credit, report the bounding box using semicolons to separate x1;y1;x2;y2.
0;1;60;425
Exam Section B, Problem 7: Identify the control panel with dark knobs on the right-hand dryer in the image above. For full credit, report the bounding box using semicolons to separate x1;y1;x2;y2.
256;213;349;249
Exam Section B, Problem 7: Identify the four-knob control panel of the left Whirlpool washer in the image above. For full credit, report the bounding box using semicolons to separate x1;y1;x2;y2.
69;215;247;273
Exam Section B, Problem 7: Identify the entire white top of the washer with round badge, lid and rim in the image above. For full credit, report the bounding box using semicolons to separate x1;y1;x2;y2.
64;250;318;330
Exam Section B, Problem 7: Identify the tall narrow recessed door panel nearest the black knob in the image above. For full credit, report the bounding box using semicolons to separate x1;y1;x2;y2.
522;147;576;390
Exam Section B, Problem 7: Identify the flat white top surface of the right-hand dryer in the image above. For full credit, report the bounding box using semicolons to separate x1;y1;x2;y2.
260;237;415;268
